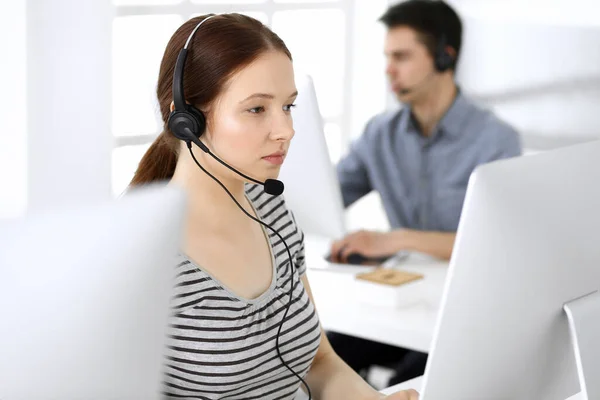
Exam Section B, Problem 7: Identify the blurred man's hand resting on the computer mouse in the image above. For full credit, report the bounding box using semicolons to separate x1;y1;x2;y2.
331;230;403;262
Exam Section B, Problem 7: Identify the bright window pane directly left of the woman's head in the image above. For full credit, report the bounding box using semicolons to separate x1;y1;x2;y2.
112;15;183;136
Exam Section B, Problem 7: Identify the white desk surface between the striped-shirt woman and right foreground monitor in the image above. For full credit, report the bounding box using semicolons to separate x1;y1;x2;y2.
306;236;448;352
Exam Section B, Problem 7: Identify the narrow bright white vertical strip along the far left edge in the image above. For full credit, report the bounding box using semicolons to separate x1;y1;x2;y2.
0;0;27;219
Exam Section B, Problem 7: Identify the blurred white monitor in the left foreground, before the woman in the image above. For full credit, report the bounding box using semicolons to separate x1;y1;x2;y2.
0;187;185;400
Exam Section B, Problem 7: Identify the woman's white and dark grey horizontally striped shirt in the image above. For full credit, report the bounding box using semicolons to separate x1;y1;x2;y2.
163;185;321;400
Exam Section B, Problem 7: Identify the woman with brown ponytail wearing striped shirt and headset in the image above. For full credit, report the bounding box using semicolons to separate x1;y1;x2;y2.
131;14;417;400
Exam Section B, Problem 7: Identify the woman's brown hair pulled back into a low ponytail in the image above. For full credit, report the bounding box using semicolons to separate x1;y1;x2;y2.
130;14;292;187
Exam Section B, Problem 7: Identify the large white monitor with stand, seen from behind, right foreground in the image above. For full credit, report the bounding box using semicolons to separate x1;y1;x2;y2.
422;142;600;400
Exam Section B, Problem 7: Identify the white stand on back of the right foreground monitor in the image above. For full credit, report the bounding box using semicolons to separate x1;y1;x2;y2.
563;291;600;400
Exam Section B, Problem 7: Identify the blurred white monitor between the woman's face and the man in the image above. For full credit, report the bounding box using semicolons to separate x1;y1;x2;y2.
279;75;345;239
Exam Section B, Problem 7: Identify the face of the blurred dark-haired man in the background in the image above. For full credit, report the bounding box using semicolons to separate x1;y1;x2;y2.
384;26;434;103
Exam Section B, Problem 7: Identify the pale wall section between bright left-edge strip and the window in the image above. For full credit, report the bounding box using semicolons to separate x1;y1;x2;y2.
27;0;115;211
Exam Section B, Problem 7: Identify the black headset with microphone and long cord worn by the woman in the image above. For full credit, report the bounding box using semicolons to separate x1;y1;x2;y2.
167;15;312;400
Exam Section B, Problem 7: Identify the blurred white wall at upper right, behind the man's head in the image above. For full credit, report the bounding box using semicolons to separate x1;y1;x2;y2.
451;0;600;149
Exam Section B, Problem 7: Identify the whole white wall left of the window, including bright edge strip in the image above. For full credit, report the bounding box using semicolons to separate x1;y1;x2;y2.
0;0;113;218
